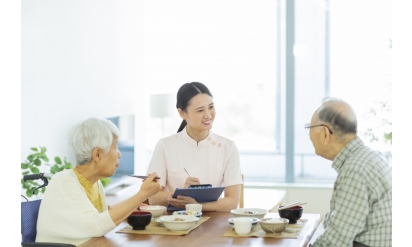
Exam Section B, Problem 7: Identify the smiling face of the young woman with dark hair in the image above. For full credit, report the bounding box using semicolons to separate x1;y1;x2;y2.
179;93;216;132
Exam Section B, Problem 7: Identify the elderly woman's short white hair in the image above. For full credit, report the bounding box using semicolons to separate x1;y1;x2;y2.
69;117;119;165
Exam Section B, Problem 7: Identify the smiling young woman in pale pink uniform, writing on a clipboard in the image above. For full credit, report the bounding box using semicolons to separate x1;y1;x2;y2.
147;82;243;211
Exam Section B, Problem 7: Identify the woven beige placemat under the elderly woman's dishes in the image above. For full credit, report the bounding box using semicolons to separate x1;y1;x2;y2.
116;217;210;236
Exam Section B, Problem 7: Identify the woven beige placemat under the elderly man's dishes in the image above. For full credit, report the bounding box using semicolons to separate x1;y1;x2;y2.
223;219;308;238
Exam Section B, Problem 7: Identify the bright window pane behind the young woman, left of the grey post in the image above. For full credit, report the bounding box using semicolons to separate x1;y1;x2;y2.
144;1;283;180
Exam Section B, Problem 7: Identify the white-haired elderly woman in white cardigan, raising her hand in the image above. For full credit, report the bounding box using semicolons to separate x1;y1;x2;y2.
36;118;160;245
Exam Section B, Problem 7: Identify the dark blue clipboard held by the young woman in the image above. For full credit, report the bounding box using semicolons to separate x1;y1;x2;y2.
166;186;225;210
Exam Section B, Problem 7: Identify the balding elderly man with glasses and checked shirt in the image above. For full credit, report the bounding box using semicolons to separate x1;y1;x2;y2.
305;98;392;247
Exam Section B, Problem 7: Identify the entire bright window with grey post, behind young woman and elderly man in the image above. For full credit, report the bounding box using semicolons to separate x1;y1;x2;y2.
143;0;391;183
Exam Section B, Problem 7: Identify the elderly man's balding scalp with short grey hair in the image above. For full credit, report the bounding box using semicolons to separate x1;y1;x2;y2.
313;98;358;139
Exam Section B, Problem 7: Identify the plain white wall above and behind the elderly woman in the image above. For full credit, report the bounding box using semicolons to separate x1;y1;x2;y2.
21;0;148;174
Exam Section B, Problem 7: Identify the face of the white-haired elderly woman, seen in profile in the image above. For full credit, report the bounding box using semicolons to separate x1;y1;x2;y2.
99;136;122;177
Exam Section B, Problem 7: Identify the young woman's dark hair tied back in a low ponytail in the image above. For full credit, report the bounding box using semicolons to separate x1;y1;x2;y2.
176;82;213;133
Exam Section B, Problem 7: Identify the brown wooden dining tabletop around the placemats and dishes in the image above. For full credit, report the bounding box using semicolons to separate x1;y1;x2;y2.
79;212;321;247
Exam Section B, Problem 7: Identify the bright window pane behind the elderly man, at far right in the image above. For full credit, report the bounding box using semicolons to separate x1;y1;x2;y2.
330;0;392;156
